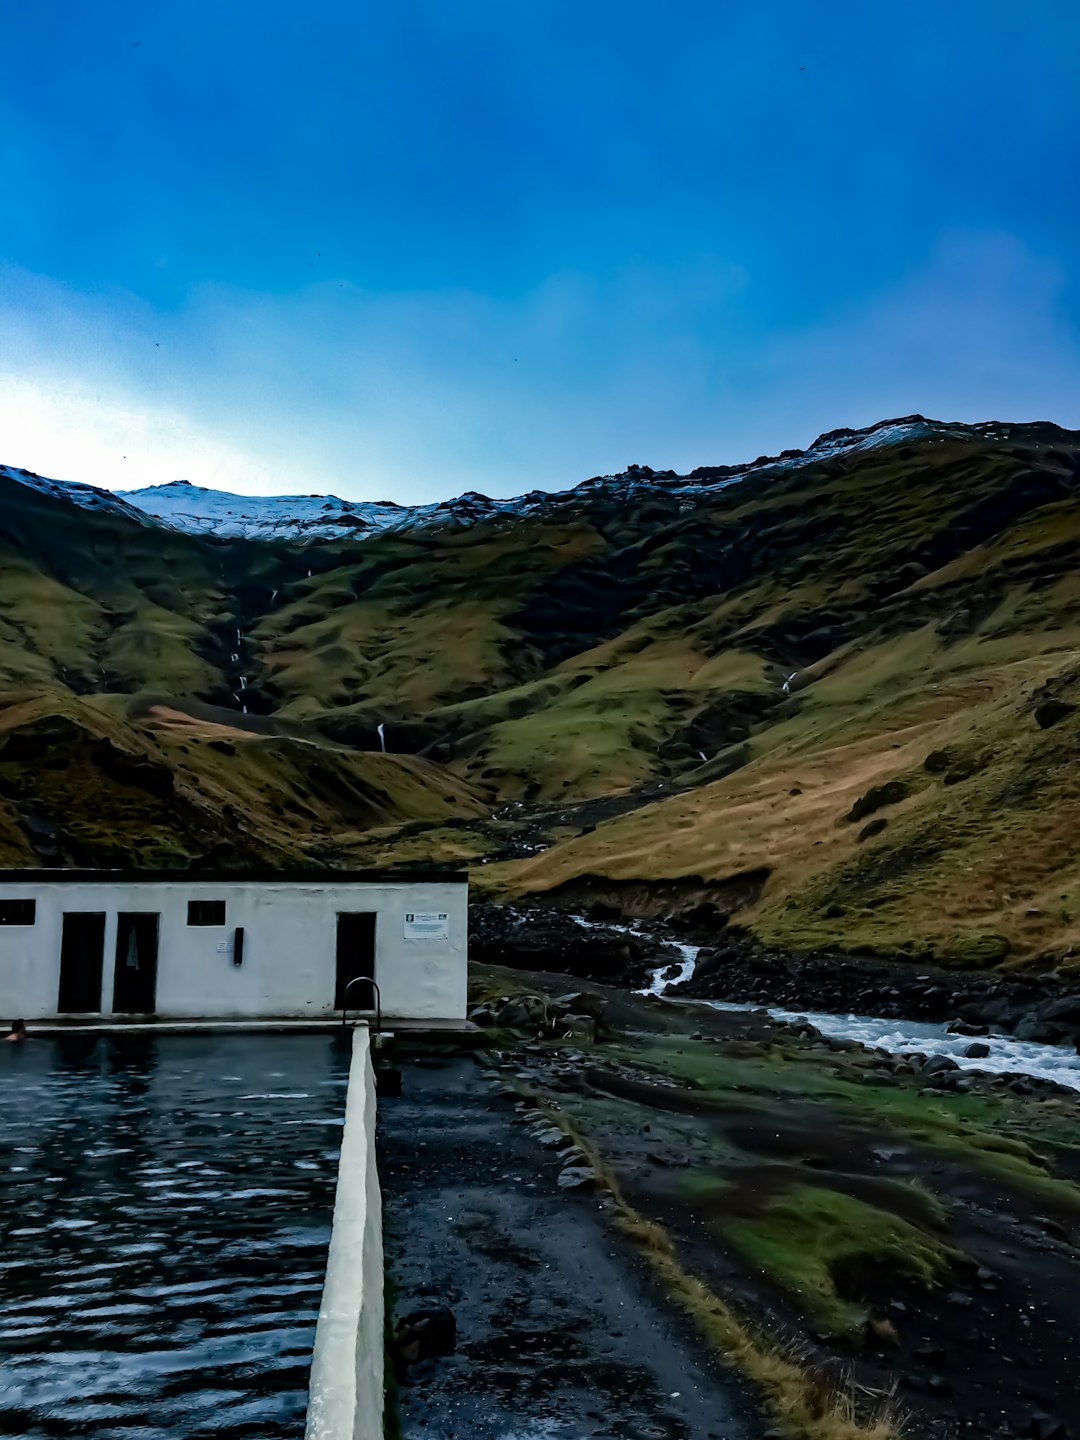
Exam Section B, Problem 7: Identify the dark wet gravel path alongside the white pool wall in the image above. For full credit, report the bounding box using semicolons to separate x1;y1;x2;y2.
379;1058;768;1440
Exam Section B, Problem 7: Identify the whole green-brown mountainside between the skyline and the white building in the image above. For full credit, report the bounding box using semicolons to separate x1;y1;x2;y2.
0;425;1080;965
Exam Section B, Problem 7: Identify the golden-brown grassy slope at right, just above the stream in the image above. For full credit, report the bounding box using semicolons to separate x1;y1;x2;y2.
492;632;1080;963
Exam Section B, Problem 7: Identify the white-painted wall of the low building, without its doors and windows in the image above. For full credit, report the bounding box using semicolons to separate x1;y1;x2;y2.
0;878;468;1020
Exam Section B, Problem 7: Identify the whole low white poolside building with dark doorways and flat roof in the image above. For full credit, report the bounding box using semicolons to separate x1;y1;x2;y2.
0;870;468;1020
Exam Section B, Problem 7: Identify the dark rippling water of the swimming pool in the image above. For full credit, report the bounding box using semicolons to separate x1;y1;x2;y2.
0;1035;348;1440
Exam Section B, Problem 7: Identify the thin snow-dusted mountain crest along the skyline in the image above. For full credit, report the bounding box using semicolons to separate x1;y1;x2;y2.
0;415;1068;540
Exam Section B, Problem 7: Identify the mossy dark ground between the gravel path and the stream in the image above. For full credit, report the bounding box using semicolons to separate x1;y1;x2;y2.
474;969;1080;1437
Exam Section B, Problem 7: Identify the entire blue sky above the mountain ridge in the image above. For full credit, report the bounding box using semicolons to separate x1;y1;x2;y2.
0;0;1080;501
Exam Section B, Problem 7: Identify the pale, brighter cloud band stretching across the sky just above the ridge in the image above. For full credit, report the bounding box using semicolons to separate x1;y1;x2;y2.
0;232;1080;501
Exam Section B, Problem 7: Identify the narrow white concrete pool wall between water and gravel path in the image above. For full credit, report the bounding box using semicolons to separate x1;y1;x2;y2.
305;1027;383;1440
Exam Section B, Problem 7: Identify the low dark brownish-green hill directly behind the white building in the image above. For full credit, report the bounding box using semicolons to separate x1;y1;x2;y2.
0;697;478;867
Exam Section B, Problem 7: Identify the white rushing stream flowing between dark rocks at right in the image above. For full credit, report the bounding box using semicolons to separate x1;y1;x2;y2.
633;944;1080;1090
